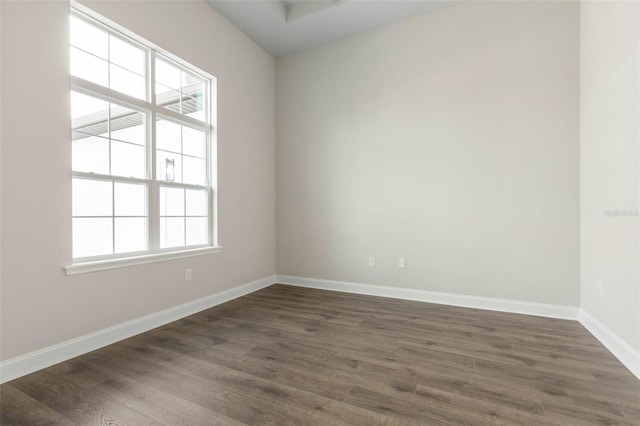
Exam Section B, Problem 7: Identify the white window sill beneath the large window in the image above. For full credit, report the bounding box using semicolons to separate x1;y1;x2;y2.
64;246;222;275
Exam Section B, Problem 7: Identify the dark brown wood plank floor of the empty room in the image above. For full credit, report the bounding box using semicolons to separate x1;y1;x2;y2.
0;285;640;426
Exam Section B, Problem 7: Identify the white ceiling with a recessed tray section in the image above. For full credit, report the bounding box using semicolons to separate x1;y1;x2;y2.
207;0;453;57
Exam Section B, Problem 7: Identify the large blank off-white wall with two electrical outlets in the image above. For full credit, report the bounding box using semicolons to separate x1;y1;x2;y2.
276;2;579;306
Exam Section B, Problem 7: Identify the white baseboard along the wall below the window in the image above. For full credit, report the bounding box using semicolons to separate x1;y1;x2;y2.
0;275;275;383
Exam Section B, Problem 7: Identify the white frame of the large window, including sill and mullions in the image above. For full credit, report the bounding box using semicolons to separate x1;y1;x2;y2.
64;2;222;275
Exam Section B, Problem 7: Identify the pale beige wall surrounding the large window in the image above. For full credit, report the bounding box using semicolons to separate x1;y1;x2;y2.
0;1;275;360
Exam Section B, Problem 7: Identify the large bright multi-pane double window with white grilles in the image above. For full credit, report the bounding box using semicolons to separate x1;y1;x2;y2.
67;9;215;273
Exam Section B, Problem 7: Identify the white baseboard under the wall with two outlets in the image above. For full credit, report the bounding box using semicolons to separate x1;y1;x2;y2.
276;275;580;320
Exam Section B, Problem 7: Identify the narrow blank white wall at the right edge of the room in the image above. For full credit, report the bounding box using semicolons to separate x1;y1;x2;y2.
580;1;640;352
